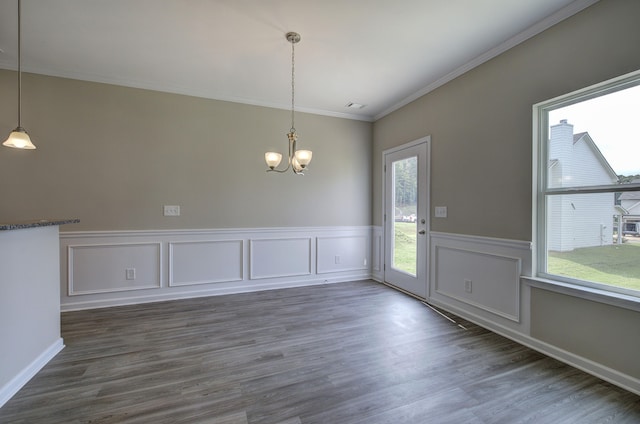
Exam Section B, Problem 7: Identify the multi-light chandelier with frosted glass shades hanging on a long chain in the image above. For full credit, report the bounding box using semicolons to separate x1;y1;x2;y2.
264;32;312;175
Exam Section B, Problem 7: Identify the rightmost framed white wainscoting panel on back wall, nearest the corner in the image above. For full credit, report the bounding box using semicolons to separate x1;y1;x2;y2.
316;236;370;274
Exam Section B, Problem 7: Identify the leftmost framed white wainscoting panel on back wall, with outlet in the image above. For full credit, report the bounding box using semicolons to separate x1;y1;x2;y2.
68;243;162;296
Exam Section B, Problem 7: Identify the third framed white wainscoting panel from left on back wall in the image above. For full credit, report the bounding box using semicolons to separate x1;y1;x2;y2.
249;237;312;280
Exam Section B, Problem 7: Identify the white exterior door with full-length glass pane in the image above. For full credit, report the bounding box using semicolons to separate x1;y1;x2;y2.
384;137;430;299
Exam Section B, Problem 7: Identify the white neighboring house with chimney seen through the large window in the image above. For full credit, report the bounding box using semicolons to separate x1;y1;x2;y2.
547;119;619;252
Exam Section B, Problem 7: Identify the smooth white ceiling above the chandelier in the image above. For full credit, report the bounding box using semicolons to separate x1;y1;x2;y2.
0;0;597;121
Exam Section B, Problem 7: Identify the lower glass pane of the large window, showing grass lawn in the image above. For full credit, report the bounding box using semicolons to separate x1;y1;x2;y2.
546;191;640;290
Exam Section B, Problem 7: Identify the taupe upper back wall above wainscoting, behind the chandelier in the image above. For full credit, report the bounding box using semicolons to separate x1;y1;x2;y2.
0;71;372;231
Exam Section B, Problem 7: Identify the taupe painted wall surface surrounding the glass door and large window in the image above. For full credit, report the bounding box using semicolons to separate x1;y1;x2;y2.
373;0;640;378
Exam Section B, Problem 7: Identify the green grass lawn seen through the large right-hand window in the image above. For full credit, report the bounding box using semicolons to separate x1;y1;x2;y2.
547;243;640;290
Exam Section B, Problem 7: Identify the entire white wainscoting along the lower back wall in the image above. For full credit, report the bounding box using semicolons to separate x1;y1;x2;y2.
60;226;372;311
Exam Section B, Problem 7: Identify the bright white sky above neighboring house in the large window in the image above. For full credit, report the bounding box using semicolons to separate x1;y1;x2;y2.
549;85;640;175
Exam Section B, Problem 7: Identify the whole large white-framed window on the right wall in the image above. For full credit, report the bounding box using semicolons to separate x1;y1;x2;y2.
534;71;640;297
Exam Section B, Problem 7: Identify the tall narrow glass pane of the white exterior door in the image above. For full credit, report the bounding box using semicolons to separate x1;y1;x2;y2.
391;156;418;276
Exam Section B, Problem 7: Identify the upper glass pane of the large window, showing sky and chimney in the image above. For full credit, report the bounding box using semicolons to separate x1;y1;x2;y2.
547;86;640;188
